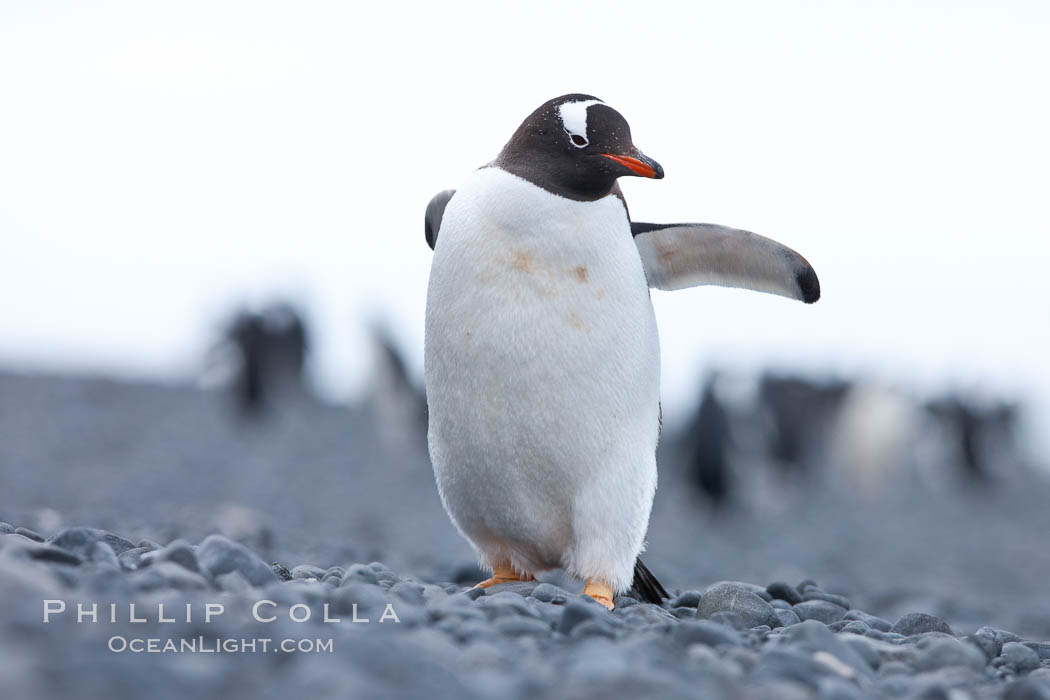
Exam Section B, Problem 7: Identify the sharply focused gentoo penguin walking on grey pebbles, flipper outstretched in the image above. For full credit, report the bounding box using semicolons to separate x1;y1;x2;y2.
424;94;819;609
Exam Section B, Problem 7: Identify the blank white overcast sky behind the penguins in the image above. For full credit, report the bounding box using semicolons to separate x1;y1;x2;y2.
0;0;1050;438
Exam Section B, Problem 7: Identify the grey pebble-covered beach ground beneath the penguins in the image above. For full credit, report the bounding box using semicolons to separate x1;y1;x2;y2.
0;374;1050;700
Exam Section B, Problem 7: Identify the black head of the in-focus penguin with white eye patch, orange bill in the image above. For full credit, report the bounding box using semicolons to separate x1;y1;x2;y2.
496;94;664;200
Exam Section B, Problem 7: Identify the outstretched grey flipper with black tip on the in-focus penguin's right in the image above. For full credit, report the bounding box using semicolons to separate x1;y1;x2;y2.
631;221;820;303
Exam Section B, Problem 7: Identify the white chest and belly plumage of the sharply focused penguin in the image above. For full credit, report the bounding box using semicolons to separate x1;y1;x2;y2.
425;168;659;578
